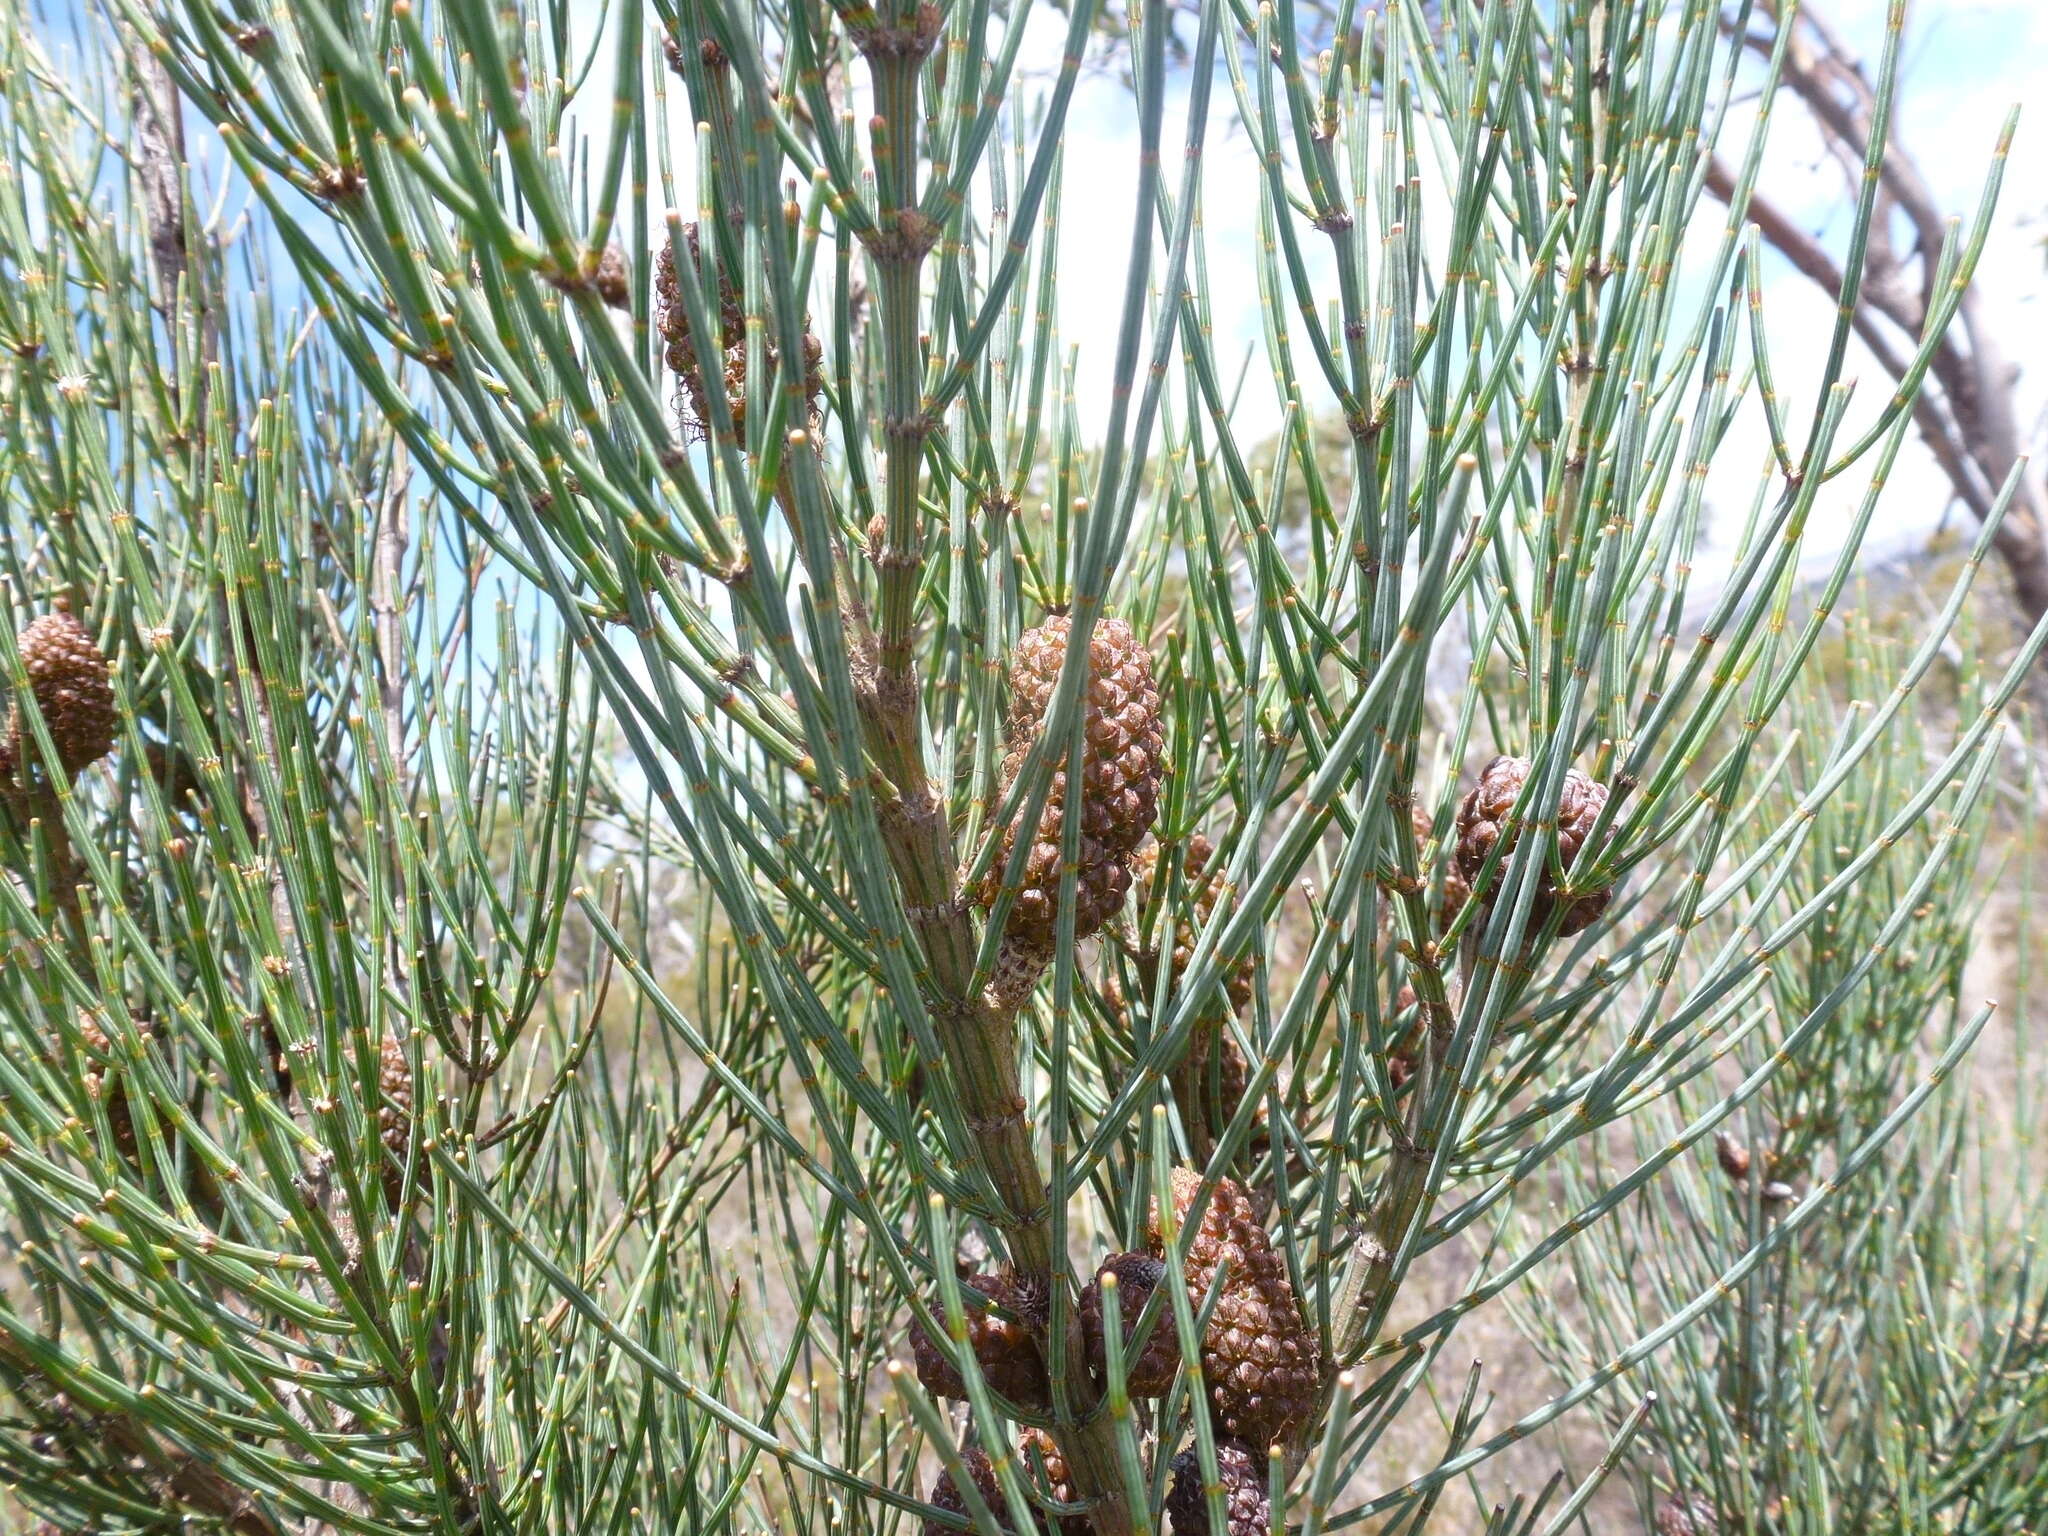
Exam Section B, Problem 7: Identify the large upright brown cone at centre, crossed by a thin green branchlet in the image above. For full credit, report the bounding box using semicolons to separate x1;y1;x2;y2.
979;614;1165;950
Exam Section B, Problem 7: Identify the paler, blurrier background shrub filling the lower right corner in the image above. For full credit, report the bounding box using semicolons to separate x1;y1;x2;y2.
1516;623;2048;1534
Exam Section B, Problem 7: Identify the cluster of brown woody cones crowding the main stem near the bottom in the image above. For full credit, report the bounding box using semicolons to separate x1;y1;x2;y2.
911;1167;1323;1536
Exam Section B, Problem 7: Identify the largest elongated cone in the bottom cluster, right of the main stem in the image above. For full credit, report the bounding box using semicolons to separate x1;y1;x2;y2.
1153;1167;1321;1446
